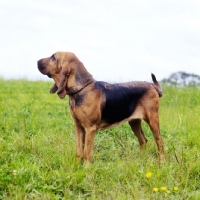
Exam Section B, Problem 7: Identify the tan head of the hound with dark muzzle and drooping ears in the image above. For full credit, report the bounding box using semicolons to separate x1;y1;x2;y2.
38;52;94;98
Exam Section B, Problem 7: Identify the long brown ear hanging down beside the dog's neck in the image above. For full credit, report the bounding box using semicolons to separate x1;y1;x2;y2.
57;68;69;99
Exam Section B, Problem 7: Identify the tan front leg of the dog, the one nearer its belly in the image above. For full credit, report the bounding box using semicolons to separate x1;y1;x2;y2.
84;126;96;163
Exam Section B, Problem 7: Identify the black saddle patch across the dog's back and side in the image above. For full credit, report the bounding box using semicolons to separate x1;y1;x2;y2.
95;81;149;124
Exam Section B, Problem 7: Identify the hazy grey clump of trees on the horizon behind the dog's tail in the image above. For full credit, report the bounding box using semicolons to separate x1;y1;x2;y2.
161;71;200;87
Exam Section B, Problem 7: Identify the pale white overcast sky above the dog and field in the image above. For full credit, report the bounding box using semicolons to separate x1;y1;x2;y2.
0;0;200;82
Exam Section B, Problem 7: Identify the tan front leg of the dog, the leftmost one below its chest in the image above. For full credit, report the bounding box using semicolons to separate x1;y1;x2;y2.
75;120;85;159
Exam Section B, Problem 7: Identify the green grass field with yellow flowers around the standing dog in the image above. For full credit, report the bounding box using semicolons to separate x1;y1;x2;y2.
0;79;200;200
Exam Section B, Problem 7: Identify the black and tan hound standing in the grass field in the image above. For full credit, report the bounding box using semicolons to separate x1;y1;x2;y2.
38;52;164;162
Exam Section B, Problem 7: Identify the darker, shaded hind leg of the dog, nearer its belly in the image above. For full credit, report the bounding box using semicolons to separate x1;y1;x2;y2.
128;119;148;150
